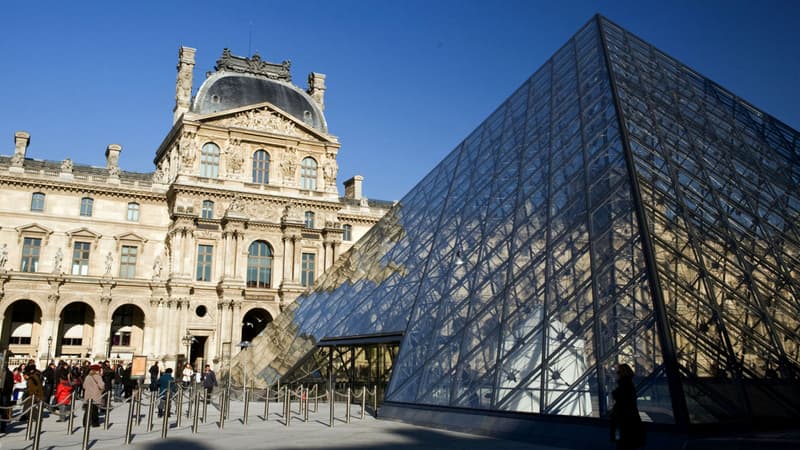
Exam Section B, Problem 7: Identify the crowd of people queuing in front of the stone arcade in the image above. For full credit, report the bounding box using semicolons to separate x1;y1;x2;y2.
0;359;217;433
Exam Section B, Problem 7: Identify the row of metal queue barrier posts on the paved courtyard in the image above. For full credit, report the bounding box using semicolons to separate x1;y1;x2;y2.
0;383;377;450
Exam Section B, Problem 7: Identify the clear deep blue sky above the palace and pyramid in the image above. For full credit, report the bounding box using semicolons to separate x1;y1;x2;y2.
0;0;800;200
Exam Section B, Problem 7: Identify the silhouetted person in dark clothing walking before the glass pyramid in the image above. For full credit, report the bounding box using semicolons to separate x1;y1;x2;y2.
611;364;645;450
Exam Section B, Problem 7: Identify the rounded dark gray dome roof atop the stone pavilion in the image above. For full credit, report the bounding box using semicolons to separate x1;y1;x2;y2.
192;72;328;133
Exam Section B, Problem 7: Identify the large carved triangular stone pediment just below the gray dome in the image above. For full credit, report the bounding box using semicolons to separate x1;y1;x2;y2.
198;102;335;142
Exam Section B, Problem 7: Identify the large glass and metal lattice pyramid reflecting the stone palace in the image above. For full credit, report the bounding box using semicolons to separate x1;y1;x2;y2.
254;16;800;424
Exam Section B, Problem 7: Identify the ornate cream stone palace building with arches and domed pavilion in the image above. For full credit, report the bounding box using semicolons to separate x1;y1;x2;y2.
0;47;391;372
